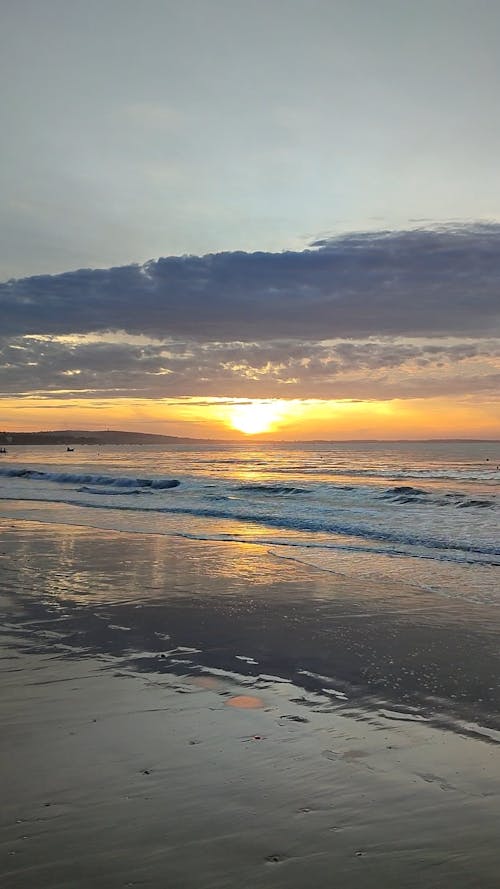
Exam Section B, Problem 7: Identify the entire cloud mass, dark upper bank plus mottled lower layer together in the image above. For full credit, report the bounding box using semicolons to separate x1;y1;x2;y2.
0;224;500;400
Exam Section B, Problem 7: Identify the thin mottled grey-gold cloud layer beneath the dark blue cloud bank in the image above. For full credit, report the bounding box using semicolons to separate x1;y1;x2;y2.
0;337;500;399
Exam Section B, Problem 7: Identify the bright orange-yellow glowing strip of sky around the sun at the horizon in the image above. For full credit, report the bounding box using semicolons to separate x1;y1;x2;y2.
0;397;500;441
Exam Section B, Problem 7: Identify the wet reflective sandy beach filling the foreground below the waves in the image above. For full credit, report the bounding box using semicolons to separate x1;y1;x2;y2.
0;520;500;889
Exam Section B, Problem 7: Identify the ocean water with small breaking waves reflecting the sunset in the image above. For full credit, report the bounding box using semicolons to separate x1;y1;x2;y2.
0;441;500;604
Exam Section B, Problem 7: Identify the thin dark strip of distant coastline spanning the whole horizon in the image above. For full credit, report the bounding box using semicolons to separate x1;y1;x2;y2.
0;429;500;447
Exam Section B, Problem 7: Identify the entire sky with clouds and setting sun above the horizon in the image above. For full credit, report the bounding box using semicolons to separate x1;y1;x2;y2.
0;0;500;439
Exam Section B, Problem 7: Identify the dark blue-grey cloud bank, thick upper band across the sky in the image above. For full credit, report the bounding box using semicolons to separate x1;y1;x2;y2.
0;224;500;343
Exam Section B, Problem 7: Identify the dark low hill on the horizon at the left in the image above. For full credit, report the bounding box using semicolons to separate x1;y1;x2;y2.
0;429;213;446
